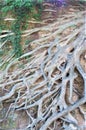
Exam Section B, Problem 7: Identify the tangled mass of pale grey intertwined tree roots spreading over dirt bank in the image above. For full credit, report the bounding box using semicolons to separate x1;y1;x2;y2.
0;8;86;130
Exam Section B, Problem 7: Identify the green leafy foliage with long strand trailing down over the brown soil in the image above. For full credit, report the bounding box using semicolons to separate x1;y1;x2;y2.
0;0;43;57
